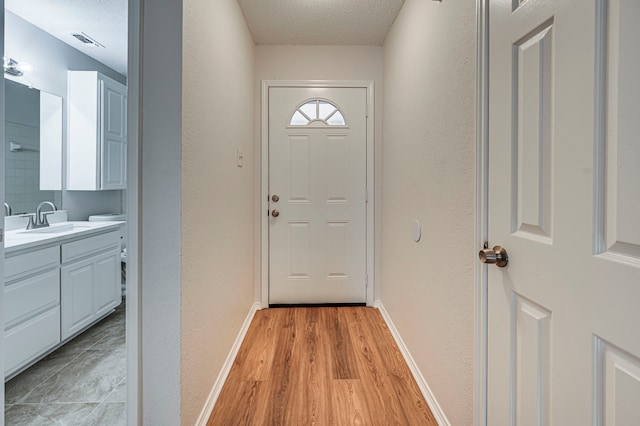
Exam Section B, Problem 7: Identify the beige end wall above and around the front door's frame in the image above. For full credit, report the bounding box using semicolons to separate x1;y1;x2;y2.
255;46;383;299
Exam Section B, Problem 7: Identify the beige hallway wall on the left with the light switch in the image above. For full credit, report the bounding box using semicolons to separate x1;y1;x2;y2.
181;0;255;425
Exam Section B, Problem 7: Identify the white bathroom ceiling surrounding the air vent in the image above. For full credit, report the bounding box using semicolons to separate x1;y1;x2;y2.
5;0;128;75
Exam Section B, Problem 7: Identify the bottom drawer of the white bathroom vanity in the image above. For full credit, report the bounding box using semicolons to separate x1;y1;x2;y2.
4;306;60;377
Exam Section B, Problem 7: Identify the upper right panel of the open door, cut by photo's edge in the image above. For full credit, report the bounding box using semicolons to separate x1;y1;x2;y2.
599;0;640;264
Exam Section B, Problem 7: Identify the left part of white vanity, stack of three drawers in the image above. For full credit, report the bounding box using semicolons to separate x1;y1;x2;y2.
3;245;60;377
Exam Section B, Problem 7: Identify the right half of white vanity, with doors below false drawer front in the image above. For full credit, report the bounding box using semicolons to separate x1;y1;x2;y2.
60;230;122;340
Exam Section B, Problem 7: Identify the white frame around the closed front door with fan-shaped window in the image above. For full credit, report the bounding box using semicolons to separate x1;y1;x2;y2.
256;80;376;308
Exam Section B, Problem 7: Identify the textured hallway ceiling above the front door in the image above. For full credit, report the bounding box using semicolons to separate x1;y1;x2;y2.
238;0;404;46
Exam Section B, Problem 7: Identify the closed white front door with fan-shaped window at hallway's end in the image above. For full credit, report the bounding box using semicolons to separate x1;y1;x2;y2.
269;87;367;304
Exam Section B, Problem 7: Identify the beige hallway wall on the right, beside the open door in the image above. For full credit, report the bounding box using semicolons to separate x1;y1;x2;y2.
380;0;476;425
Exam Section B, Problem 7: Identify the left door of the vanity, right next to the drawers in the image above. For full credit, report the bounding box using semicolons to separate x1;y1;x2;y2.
61;259;96;340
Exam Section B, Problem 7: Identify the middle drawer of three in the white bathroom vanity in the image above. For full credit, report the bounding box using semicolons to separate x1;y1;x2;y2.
4;268;60;329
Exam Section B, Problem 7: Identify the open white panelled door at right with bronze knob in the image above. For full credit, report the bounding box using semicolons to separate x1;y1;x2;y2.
487;0;640;425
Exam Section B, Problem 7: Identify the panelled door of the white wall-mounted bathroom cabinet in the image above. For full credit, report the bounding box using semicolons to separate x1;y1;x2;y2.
101;80;127;189
